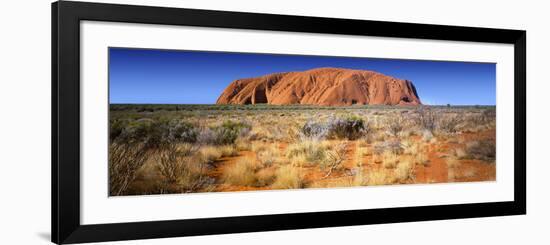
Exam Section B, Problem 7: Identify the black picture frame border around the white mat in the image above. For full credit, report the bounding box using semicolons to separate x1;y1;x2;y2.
51;1;526;244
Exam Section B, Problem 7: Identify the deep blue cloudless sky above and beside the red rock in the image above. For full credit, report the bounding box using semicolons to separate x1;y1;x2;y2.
109;48;496;105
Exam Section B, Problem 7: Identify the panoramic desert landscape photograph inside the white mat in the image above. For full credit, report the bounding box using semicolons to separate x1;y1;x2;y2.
108;47;497;196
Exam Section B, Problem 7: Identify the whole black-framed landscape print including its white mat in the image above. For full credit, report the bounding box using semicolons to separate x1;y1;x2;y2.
52;1;526;244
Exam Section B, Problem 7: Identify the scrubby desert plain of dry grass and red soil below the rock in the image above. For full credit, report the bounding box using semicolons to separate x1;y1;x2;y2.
109;105;496;196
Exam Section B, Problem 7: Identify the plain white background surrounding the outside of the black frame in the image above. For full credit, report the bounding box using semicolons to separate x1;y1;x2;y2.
0;0;550;245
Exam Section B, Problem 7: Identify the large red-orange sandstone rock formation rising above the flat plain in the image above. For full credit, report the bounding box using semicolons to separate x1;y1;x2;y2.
216;68;421;106
